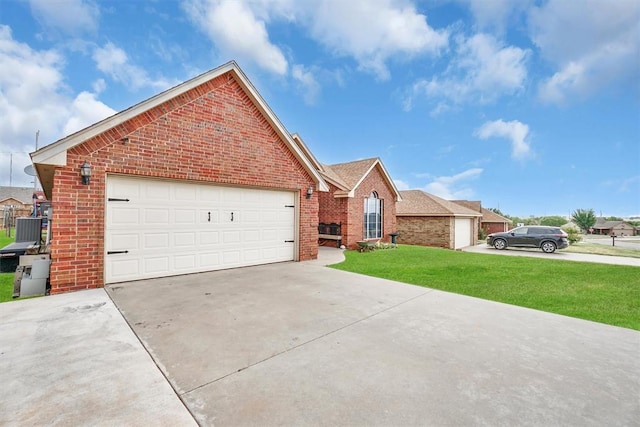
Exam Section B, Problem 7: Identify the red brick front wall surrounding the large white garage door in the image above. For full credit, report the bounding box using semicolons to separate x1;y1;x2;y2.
51;74;318;293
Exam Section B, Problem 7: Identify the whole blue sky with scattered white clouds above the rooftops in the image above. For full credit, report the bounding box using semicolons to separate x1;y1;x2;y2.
0;0;640;216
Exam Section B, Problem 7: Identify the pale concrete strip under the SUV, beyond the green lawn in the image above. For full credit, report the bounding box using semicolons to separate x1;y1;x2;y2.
462;243;640;267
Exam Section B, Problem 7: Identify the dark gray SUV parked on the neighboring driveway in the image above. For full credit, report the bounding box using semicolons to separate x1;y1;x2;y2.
487;225;569;254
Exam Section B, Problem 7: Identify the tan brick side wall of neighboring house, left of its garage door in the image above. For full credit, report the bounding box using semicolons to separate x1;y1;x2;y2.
398;216;455;249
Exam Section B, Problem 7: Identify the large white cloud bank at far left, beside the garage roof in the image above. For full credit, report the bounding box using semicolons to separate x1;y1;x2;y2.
0;25;113;186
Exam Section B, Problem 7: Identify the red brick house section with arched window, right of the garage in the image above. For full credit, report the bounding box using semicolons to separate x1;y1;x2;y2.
294;142;400;248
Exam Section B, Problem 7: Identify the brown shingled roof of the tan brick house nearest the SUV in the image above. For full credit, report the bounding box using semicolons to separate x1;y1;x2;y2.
396;190;482;217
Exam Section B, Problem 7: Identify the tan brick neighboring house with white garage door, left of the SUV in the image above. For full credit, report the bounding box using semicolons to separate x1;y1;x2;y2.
396;190;482;249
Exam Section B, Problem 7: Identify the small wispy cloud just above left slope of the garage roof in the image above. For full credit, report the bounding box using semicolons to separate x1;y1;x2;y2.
92;42;179;90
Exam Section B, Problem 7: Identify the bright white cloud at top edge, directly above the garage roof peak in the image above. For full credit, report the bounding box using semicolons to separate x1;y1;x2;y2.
183;0;289;75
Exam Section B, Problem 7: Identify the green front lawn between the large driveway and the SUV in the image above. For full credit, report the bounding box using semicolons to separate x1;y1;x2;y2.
332;245;640;330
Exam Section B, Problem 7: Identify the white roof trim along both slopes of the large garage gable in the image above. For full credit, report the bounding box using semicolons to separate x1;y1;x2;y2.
31;61;329;191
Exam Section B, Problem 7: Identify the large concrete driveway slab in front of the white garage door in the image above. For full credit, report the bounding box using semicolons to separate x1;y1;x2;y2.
107;248;640;426
